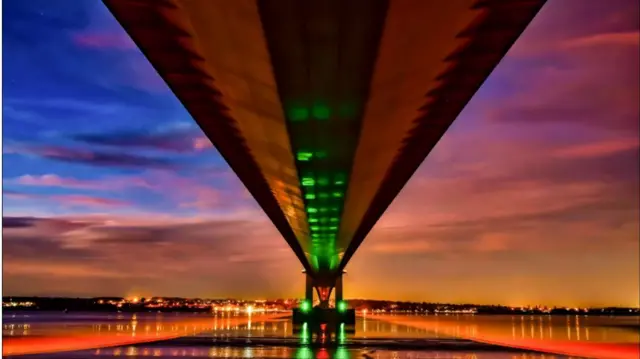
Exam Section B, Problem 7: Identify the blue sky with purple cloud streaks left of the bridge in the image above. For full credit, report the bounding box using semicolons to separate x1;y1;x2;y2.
3;1;248;218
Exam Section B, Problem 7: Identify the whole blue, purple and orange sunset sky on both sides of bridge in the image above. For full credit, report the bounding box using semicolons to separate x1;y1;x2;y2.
2;0;640;306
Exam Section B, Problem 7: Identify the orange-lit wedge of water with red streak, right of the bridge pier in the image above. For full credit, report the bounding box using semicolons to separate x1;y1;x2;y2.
372;315;640;358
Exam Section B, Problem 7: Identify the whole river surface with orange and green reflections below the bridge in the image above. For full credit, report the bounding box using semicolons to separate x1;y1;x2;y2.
2;312;640;359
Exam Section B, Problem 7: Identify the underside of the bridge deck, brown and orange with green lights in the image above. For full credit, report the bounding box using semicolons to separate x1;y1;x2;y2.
105;0;544;287
